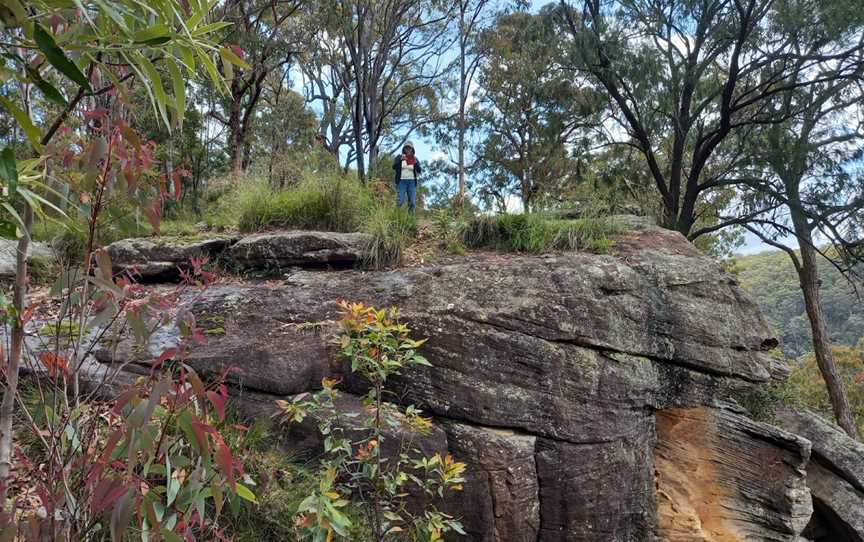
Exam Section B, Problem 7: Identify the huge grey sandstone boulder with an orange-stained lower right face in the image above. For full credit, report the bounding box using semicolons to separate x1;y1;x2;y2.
93;226;844;542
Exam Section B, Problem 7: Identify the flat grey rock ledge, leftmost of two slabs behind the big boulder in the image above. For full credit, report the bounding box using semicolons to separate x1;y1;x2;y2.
105;237;235;282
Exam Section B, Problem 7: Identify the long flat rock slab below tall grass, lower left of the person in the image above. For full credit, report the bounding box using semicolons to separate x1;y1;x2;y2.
230;230;369;271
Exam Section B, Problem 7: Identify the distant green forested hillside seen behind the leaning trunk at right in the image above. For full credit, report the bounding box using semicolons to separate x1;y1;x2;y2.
735;251;864;357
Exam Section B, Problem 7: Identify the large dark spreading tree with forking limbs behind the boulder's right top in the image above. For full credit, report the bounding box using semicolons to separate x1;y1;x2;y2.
559;0;858;238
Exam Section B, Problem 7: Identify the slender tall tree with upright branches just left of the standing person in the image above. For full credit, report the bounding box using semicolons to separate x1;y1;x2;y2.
333;0;452;179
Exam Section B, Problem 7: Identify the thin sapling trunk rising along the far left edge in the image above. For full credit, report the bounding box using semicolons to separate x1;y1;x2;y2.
0;203;33;512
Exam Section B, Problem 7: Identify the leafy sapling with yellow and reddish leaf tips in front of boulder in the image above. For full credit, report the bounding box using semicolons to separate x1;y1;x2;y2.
278;302;465;542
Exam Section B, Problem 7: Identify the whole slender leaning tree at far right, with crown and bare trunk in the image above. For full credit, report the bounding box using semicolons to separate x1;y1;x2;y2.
730;26;864;438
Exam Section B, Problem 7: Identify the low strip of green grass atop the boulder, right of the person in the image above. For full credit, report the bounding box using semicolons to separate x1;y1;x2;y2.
461;214;621;254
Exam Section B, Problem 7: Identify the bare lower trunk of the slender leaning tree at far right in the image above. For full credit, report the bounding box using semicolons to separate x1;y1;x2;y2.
792;209;860;440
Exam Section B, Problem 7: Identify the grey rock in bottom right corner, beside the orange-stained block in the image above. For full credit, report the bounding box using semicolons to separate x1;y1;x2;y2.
776;407;864;542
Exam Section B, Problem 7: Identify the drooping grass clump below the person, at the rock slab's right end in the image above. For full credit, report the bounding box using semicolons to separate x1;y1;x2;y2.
363;204;417;269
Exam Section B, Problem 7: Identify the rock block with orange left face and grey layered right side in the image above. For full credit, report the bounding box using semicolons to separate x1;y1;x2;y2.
654;407;811;542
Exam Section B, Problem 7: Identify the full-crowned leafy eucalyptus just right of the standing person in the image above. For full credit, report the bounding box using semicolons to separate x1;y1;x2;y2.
470;12;599;211
